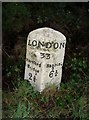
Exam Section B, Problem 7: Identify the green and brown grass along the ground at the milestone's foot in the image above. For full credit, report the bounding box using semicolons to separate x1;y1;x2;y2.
3;77;88;120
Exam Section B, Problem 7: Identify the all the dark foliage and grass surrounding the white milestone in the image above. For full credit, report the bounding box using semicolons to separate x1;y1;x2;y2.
2;3;89;120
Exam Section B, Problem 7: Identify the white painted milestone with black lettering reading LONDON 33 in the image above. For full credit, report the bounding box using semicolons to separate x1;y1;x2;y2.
24;27;66;92
